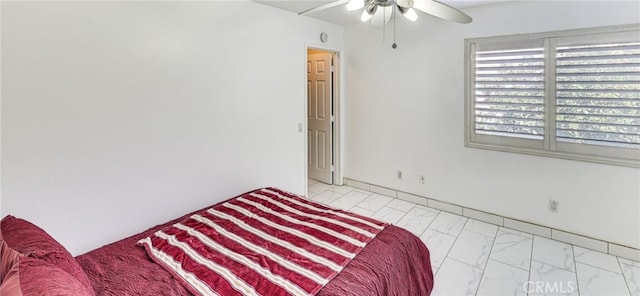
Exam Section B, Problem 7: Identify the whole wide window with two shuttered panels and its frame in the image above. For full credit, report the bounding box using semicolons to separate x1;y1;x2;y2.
465;25;640;167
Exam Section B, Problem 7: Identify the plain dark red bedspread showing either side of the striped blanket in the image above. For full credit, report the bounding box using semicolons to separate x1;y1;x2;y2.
76;188;433;296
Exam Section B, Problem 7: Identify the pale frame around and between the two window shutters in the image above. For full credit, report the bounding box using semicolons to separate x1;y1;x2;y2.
464;24;640;168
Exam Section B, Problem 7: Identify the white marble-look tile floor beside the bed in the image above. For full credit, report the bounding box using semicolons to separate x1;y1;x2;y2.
309;180;640;296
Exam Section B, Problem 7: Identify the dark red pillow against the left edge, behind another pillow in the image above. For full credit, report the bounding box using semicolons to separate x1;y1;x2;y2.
0;216;95;295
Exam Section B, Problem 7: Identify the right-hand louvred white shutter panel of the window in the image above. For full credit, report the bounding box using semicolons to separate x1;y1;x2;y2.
556;36;640;149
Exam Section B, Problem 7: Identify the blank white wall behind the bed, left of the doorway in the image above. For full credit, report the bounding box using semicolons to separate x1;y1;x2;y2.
1;1;342;254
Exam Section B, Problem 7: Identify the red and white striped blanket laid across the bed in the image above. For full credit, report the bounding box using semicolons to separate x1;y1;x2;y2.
138;188;387;296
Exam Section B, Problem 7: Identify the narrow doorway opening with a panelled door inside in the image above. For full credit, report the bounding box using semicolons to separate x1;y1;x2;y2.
306;48;342;185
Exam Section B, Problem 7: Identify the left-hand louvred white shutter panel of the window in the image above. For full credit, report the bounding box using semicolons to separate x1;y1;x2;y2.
474;47;544;140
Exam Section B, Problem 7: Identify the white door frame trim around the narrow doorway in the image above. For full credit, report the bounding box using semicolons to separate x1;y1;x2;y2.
302;43;345;196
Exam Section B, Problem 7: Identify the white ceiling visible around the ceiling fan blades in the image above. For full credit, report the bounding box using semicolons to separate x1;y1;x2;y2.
253;0;510;26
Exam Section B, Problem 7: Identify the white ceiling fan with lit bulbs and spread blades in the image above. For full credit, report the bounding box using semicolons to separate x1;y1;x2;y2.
299;0;471;26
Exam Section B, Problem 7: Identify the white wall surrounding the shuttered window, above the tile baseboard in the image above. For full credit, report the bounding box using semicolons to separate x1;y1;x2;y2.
345;1;640;248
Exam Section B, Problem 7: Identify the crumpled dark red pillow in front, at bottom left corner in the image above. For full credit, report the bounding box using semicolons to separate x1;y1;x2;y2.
0;256;93;296
